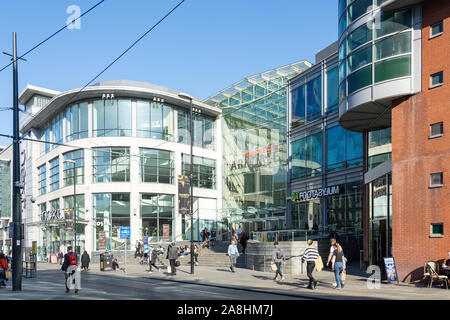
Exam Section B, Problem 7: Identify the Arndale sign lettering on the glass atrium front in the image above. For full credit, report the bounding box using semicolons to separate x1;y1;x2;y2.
230;145;279;170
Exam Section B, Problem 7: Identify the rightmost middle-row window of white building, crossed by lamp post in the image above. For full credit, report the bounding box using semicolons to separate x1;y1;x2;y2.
182;154;216;189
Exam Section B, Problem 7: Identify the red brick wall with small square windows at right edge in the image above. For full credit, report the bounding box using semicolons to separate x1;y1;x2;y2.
392;0;450;281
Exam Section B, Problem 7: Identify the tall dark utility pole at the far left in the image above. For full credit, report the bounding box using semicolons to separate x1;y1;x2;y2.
3;32;26;291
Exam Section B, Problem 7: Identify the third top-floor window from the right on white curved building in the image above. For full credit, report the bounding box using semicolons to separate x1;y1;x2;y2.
92;99;131;137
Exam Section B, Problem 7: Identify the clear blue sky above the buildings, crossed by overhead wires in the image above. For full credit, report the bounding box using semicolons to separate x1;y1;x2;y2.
0;0;337;145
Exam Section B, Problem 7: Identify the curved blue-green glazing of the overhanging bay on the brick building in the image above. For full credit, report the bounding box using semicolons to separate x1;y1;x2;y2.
339;4;412;101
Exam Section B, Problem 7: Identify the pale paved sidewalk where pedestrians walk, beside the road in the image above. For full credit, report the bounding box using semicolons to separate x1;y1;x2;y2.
29;259;450;300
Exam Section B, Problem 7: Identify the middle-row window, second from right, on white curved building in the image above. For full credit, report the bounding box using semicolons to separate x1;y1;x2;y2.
140;148;174;183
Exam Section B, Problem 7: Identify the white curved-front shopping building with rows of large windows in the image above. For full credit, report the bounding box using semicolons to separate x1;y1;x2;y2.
0;81;222;259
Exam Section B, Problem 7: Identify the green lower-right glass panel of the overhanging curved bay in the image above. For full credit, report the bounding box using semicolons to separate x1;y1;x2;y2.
375;55;411;82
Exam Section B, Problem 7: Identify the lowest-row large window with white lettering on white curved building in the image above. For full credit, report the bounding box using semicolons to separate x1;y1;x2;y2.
92;193;130;250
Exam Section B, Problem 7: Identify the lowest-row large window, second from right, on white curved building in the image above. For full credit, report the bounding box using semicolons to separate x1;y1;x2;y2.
140;193;175;242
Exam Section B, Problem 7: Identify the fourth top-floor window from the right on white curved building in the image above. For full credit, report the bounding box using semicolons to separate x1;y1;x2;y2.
65;102;89;141
